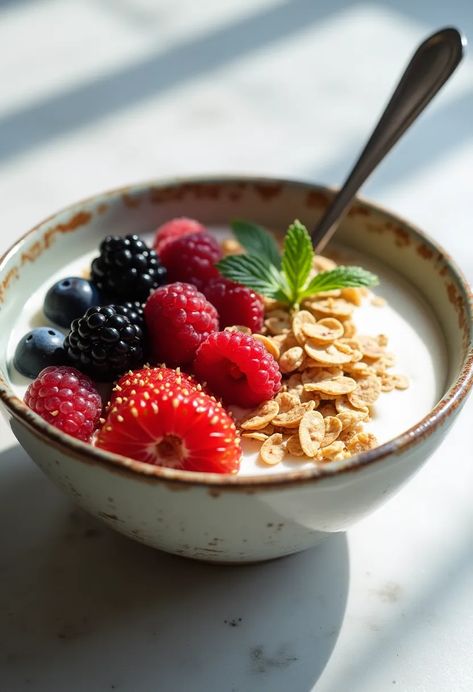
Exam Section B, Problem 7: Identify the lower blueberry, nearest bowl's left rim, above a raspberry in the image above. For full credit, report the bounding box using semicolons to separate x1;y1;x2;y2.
13;327;68;379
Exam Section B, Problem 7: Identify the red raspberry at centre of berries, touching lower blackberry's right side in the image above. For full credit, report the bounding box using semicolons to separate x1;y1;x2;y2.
145;282;218;366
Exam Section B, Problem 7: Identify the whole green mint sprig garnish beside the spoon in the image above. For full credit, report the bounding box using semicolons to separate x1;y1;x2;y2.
216;220;378;307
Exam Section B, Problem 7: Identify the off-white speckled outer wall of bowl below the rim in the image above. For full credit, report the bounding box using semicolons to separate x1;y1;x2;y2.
11;406;454;563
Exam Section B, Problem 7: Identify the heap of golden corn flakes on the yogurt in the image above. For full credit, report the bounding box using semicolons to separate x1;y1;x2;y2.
233;255;409;466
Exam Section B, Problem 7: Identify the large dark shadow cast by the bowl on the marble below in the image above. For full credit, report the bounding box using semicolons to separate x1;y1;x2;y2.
0;447;349;692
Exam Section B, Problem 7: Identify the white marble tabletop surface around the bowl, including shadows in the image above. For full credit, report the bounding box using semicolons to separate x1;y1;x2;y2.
0;0;473;692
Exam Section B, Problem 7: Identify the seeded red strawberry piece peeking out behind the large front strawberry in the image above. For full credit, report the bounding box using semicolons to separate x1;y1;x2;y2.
108;368;198;409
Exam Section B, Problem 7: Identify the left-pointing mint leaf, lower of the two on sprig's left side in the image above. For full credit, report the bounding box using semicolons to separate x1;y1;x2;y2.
215;255;288;302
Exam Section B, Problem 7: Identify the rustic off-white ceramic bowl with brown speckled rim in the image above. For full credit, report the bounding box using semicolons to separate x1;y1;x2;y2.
0;177;473;562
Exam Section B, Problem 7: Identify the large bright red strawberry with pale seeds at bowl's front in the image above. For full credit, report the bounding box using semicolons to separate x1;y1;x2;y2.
96;382;241;473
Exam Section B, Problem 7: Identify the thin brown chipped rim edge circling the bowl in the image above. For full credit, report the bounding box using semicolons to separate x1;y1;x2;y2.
0;174;473;491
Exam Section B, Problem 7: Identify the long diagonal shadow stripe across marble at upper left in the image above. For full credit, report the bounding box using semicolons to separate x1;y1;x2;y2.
0;0;346;160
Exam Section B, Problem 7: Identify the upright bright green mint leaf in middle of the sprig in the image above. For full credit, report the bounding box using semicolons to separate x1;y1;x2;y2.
281;220;314;303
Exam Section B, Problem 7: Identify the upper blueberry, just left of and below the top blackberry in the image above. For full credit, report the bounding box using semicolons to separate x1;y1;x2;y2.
43;276;100;327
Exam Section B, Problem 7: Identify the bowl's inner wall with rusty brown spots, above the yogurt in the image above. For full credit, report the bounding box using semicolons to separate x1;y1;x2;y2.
0;180;471;400
